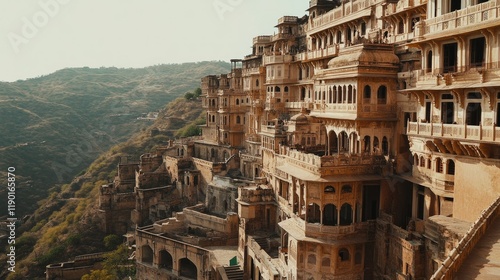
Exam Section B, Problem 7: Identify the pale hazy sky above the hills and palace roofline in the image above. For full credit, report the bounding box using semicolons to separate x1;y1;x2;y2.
0;0;309;81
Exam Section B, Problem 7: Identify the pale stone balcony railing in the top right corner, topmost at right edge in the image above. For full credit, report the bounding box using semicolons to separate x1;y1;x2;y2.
418;1;499;36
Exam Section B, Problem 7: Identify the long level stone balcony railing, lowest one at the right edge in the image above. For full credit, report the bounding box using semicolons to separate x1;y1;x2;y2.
407;122;500;143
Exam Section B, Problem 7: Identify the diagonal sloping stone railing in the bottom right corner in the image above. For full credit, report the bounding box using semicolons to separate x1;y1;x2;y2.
431;197;500;279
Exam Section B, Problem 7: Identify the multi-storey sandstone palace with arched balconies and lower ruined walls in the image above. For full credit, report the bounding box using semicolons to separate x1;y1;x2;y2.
95;0;500;280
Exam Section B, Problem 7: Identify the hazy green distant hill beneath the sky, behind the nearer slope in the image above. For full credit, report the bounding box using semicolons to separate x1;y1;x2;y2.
0;62;229;218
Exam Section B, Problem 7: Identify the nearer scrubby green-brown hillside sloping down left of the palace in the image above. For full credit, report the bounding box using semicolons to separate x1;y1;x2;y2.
0;96;207;280
